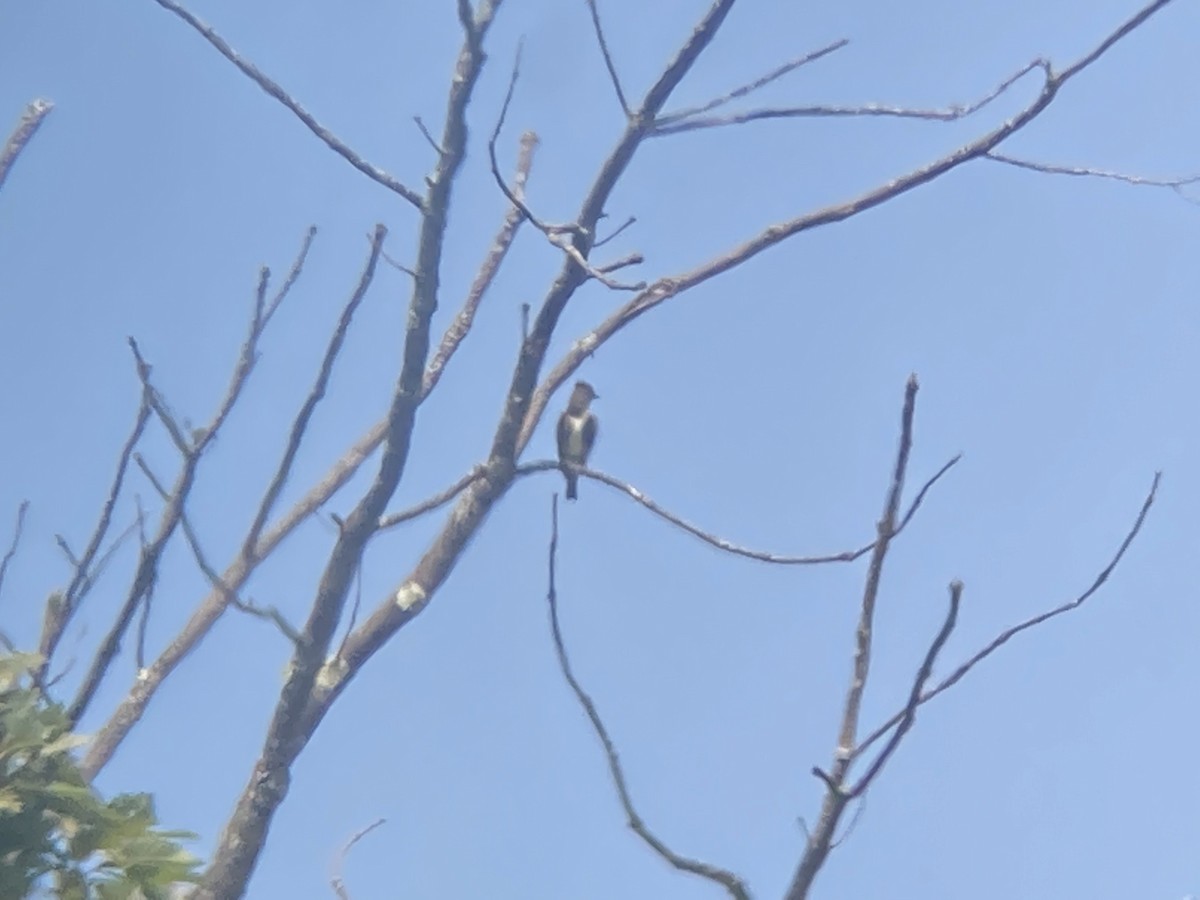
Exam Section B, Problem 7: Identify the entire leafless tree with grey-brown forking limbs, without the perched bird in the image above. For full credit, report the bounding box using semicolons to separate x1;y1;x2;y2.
0;0;1185;900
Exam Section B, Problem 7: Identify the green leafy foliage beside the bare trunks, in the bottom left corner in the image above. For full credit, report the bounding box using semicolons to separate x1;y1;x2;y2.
0;653;199;900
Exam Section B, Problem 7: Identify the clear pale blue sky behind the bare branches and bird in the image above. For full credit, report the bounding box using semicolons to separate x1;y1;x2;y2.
0;0;1200;900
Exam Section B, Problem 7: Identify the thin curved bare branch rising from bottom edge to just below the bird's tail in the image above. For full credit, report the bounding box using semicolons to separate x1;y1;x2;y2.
546;493;750;900
